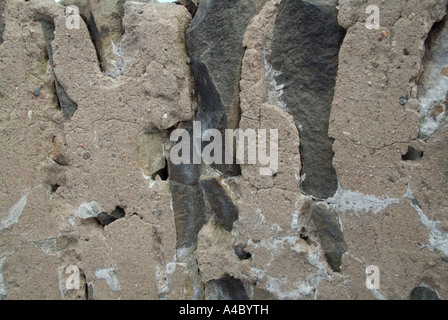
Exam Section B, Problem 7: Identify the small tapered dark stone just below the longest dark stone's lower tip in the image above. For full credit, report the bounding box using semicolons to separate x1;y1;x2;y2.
310;204;347;272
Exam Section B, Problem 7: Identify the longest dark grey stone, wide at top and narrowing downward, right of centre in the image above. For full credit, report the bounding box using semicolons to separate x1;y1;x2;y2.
271;0;345;199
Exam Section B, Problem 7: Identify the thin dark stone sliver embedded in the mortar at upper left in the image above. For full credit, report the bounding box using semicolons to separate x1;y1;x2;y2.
42;20;78;119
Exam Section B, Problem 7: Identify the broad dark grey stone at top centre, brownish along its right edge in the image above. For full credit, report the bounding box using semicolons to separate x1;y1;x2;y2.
187;0;256;176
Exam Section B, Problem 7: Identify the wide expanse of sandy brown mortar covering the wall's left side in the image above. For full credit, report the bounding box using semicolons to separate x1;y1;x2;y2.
0;1;194;299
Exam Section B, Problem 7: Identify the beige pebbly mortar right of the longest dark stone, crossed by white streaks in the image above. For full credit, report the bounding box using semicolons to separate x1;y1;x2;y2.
329;1;447;299
